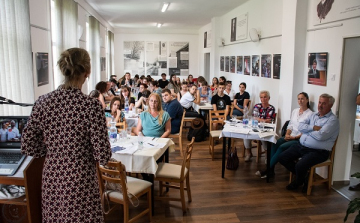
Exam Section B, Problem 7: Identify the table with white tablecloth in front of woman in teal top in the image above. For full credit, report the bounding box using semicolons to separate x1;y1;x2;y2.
111;136;175;215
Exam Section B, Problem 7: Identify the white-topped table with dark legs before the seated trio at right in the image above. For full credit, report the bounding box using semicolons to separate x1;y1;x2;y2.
219;123;278;182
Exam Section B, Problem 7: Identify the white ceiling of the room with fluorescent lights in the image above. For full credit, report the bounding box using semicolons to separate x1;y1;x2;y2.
86;0;247;32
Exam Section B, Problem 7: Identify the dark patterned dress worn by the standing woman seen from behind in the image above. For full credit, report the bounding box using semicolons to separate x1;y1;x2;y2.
22;88;111;223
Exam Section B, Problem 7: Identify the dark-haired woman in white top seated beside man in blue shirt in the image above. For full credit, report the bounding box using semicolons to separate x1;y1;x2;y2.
255;92;312;178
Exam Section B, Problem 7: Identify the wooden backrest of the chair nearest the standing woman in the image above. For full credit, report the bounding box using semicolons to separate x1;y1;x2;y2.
97;161;129;202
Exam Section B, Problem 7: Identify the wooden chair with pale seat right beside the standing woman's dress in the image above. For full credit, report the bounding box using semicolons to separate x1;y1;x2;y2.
97;162;152;223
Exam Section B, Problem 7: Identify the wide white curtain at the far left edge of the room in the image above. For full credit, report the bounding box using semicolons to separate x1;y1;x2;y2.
0;0;34;115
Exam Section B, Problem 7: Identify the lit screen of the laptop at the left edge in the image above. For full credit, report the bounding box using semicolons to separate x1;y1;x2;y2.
0;116;29;148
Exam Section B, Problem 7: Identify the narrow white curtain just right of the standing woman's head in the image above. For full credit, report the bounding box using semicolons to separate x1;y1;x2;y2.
89;16;101;91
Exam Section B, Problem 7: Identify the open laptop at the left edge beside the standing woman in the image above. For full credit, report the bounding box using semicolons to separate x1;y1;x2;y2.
0;116;29;176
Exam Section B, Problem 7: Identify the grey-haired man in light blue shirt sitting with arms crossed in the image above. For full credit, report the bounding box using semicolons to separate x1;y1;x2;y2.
279;94;339;190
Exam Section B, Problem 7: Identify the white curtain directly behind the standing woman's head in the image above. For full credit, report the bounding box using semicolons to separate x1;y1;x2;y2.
52;0;79;89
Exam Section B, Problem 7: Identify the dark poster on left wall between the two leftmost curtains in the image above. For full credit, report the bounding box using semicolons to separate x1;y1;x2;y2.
35;53;49;87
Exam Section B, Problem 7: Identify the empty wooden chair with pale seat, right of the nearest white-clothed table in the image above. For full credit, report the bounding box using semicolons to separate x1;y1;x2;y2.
154;137;195;213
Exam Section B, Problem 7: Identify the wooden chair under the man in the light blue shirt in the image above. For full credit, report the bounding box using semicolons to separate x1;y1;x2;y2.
289;139;337;195
